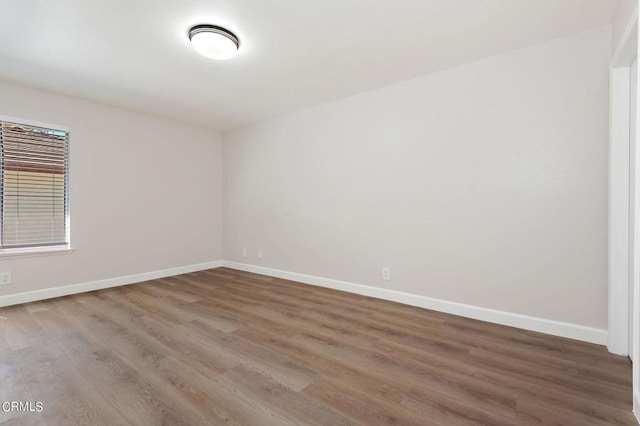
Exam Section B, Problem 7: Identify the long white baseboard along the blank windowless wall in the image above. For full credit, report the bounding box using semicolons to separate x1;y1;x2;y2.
223;260;607;345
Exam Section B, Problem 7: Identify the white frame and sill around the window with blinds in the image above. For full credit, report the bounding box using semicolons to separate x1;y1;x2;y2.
0;114;74;258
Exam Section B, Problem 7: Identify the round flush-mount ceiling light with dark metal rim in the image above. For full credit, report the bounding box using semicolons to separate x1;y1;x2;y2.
189;25;240;60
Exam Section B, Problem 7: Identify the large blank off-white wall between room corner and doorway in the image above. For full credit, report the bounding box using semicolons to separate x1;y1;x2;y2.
223;26;611;329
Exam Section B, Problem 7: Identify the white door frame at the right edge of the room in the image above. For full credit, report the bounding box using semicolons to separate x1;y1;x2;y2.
607;7;640;418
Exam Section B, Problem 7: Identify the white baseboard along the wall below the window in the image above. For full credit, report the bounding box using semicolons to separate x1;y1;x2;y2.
0;260;222;307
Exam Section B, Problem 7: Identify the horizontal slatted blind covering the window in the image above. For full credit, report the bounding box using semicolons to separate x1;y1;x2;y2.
0;120;69;249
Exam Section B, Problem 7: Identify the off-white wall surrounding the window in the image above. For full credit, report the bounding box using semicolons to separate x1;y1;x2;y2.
0;82;222;296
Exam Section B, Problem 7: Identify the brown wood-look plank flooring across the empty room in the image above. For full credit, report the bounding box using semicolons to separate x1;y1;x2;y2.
0;268;636;426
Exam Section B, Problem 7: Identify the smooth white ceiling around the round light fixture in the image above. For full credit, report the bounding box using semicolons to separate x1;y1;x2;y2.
0;0;618;131
